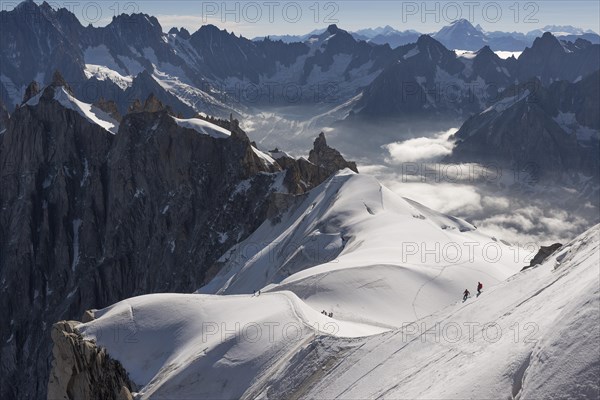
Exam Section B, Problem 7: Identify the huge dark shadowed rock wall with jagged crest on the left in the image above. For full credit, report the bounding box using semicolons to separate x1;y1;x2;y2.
0;72;356;399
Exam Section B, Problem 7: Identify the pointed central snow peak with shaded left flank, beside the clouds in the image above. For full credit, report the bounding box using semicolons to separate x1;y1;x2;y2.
199;170;523;328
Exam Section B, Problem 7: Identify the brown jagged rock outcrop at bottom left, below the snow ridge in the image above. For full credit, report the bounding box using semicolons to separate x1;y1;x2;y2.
48;321;135;400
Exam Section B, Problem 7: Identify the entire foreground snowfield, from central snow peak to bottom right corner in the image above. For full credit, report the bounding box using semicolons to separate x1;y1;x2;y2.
78;171;600;399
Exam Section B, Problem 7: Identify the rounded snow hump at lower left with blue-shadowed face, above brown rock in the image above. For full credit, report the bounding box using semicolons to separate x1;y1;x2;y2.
78;292;381;399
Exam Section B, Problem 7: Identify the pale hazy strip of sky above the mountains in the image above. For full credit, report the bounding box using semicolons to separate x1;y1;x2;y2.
30;0;600;37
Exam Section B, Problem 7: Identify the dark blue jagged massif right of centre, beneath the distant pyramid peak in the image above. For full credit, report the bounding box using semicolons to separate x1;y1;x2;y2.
353;33;600;120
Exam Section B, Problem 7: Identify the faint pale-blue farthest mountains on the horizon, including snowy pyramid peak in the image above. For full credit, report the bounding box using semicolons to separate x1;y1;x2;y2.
254;19;600;52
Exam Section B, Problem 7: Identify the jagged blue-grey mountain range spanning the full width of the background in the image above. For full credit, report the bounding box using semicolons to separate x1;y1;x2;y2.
0;1;600;123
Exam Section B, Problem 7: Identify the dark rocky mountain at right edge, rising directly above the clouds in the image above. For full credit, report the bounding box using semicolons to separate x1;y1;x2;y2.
448;71;600;179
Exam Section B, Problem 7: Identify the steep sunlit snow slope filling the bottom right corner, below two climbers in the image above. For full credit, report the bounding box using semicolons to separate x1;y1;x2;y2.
296;226;600;400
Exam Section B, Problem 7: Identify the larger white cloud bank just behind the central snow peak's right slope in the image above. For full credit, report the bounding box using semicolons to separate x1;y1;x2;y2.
359;164;595;246
